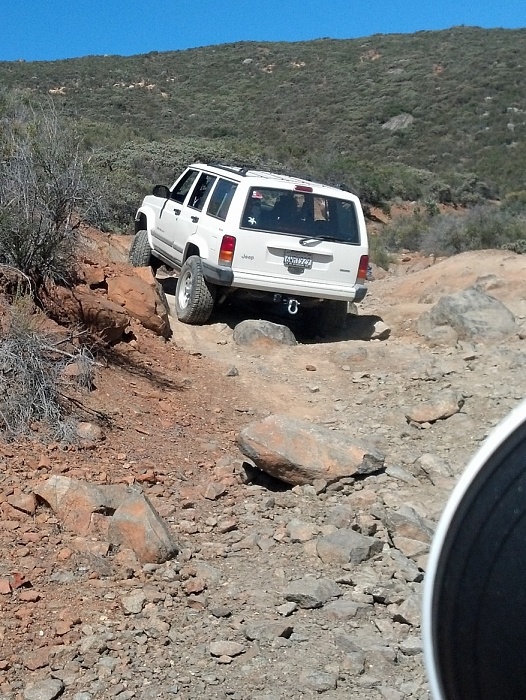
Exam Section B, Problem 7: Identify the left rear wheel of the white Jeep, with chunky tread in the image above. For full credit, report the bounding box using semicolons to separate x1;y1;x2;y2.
175;255;216;326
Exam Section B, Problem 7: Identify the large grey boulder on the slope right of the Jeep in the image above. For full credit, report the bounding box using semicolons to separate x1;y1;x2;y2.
416;287;519;340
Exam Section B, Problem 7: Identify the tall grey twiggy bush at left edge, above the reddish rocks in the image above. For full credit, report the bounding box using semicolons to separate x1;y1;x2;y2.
0;98;104;287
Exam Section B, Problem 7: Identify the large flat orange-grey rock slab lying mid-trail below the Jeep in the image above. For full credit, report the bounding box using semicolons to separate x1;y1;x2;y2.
238;415;385;485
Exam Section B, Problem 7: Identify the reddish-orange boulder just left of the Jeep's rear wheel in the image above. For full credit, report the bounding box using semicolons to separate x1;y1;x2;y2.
106;267;171;338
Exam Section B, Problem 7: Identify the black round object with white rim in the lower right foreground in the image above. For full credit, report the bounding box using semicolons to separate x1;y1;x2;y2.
422;401;526;700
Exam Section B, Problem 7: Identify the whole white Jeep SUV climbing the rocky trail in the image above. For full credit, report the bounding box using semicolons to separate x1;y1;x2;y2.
130;163;369;335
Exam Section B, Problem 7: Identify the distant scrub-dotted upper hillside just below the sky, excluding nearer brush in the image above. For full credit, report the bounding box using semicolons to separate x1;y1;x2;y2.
0;27;526;197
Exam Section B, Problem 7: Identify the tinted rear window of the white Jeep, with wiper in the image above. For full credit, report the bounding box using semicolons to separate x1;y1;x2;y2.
241;187;360;245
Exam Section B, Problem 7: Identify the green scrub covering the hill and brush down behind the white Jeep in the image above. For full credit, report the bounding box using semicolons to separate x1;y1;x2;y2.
0;27;526;262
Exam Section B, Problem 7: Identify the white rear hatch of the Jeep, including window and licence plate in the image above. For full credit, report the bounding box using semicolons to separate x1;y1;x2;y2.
233;186;368;299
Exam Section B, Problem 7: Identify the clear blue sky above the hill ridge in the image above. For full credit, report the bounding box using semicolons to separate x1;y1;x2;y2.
4;0;526;61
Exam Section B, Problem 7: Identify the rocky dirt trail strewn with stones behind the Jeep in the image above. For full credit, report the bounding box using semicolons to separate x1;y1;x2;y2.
0;245;526;700
